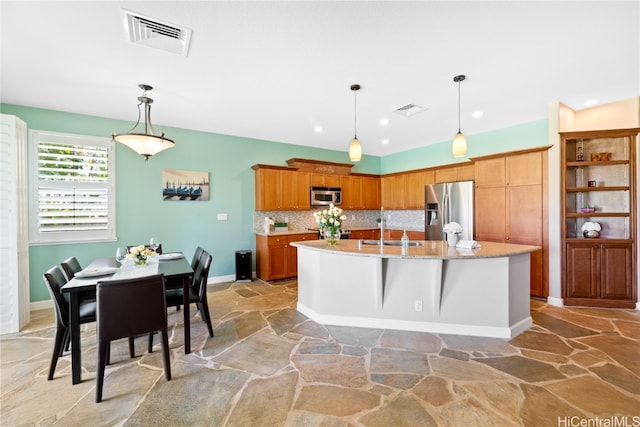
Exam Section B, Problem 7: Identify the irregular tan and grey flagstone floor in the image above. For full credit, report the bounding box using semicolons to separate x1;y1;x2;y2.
0;280;640;427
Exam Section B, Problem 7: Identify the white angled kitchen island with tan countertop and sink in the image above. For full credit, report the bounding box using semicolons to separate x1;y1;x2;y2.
292;240;541;338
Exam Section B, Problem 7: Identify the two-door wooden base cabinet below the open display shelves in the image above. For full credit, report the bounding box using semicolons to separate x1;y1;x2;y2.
564;239;635;308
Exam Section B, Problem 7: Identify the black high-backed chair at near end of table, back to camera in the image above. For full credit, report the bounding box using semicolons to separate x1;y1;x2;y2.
96;274;171;403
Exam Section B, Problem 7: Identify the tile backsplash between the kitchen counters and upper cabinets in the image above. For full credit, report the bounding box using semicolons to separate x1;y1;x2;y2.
253;210;424;233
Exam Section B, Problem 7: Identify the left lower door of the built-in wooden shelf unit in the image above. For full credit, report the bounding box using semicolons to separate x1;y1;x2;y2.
565;243;600;298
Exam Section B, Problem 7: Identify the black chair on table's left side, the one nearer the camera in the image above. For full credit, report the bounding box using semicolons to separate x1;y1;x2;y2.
43;266;96;380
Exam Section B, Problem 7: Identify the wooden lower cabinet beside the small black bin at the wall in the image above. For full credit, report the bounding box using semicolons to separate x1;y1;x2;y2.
256;233;318;281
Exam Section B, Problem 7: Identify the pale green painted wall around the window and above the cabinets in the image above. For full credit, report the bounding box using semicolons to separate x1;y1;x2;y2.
0;104;547;302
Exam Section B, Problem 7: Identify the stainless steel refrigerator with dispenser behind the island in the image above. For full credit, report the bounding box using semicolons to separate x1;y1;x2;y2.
424;181;474;240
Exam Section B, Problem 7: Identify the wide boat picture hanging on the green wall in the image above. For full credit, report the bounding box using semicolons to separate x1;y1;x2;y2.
162;169;209;201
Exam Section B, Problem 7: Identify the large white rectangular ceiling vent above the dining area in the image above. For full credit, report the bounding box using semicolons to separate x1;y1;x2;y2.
122;9;192;56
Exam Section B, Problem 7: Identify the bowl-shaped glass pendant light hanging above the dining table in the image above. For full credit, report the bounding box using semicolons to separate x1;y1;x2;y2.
112;84;176;161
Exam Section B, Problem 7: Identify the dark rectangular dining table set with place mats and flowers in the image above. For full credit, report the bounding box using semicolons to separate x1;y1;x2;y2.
61;253;193;384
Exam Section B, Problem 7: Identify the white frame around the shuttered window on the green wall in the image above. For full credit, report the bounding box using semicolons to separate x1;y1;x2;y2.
28;129;116;245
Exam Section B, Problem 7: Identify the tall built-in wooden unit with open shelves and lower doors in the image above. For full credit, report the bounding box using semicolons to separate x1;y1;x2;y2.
560;128;640;308
